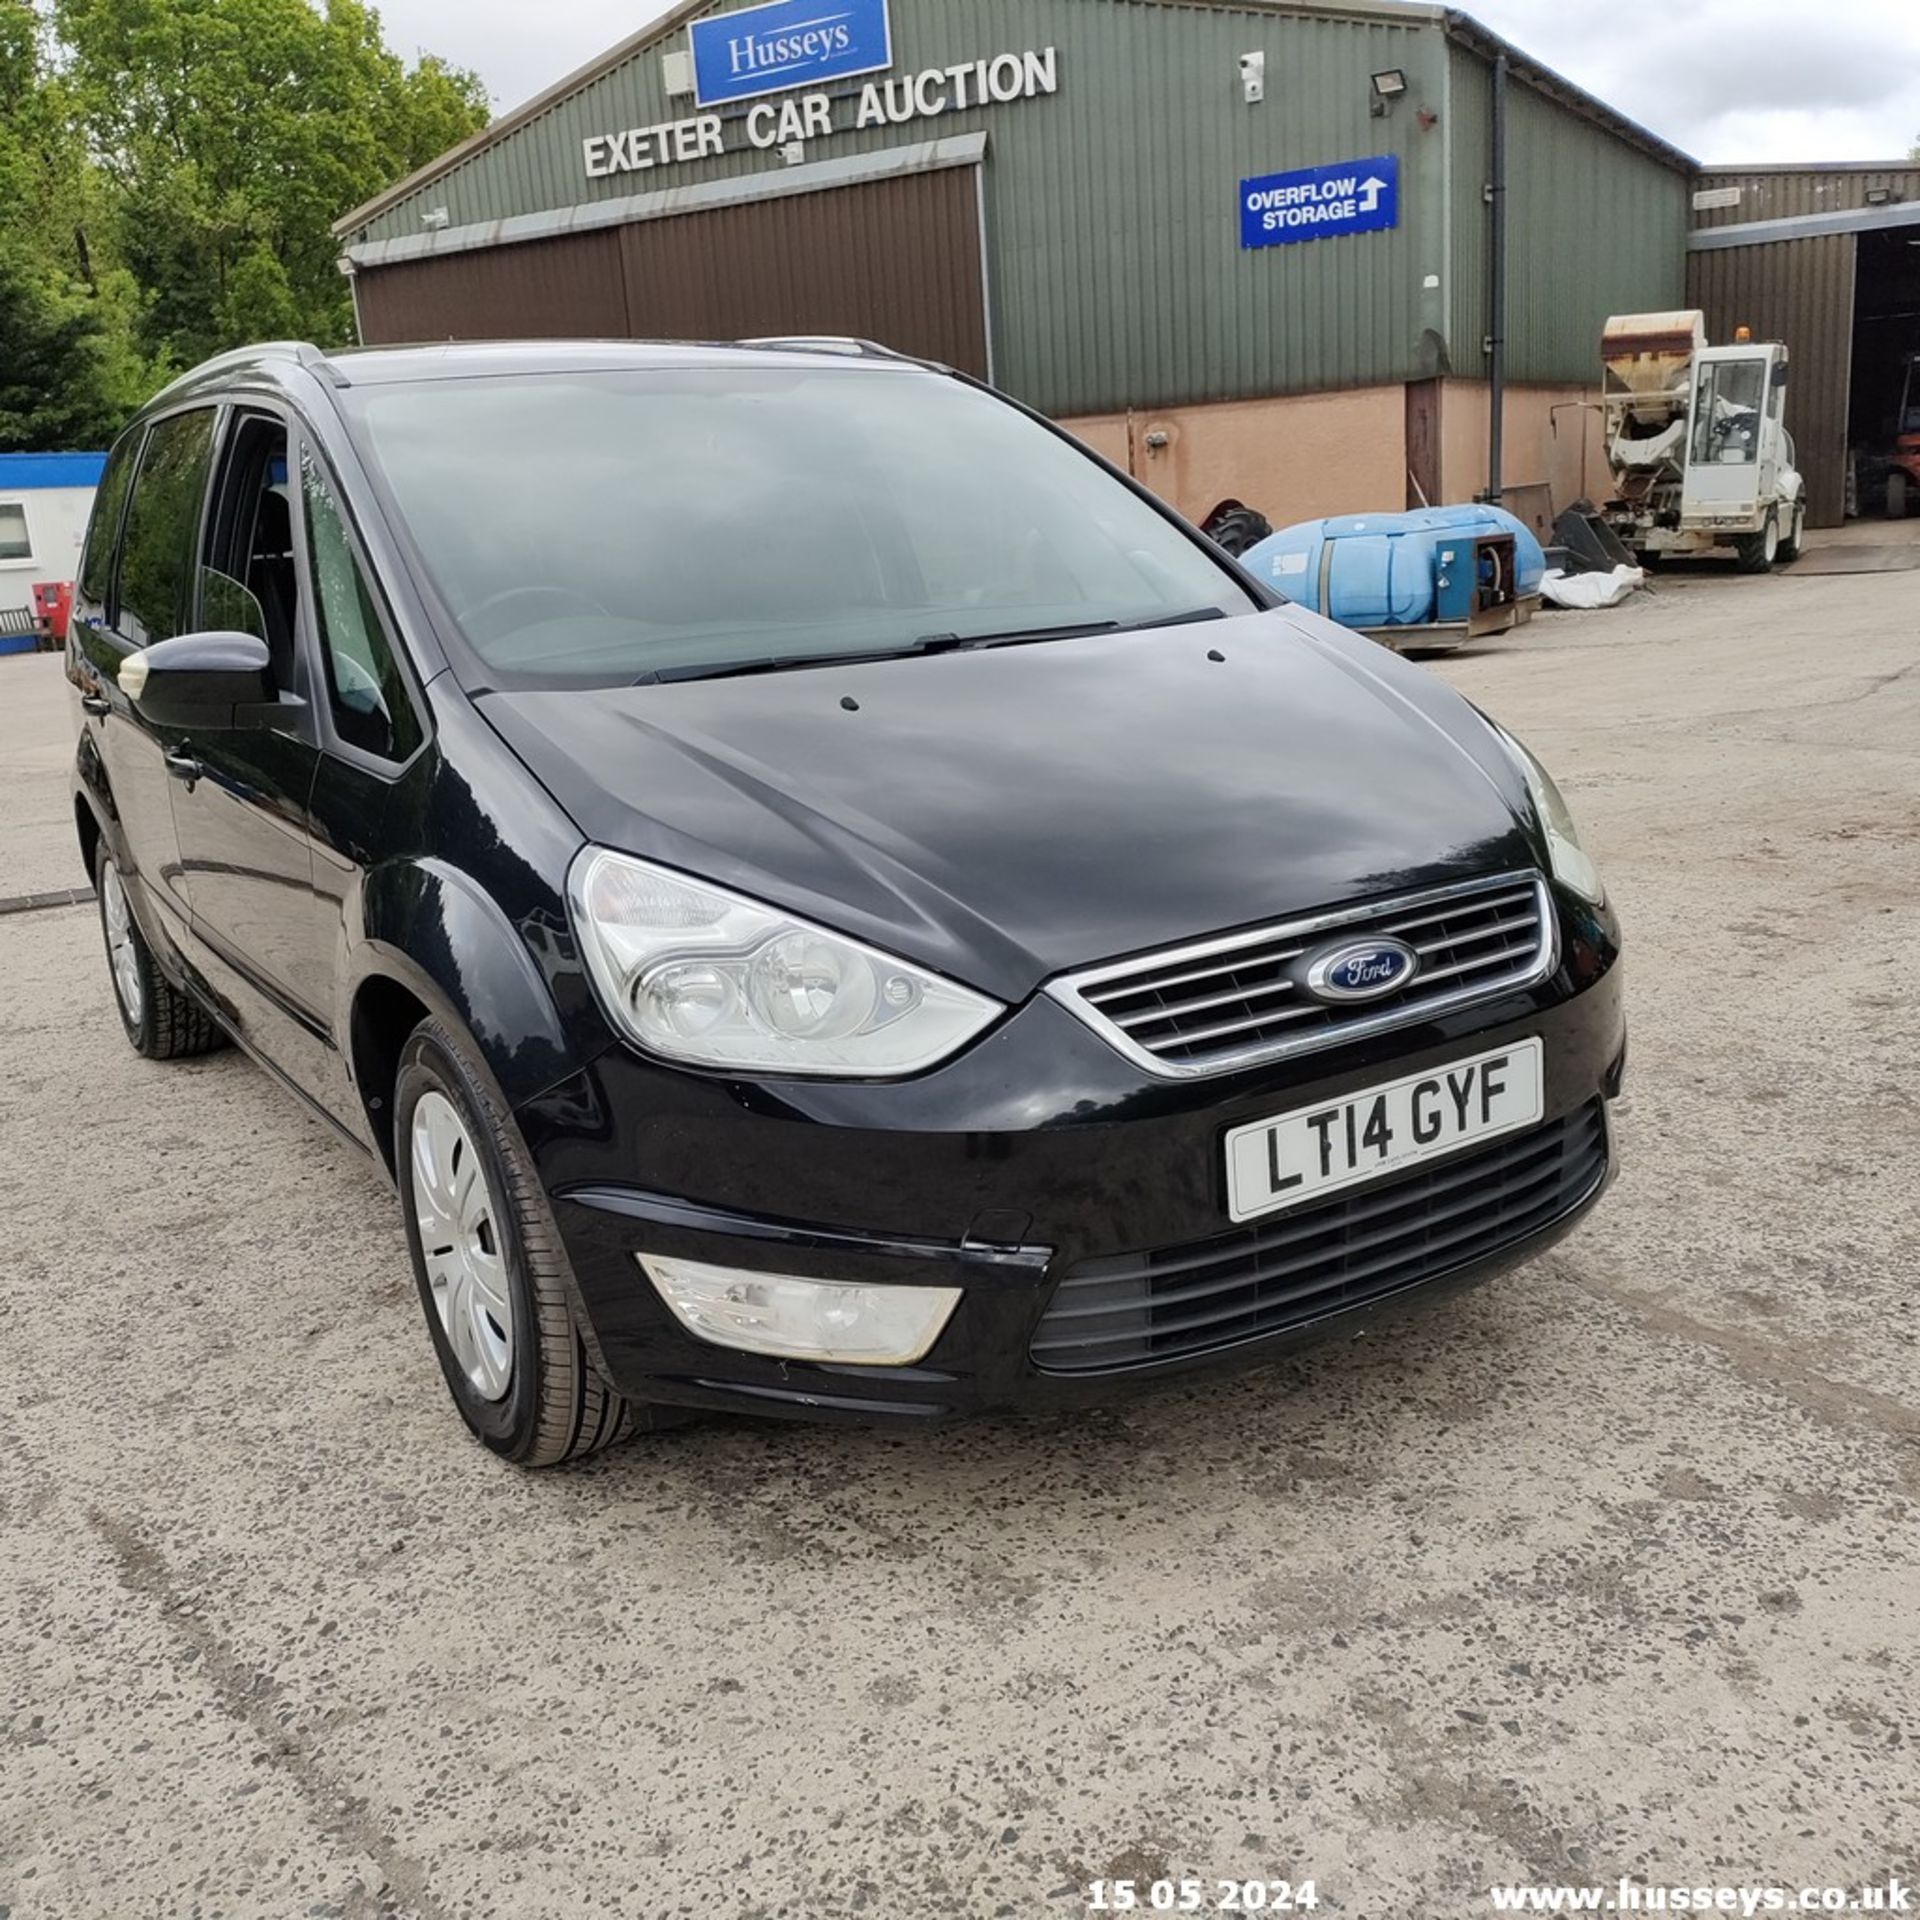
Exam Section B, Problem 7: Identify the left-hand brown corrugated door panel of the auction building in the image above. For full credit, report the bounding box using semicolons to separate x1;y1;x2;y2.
353;232;628;346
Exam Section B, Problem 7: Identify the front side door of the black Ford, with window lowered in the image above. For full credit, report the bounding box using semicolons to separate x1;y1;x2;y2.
173;403;342;1108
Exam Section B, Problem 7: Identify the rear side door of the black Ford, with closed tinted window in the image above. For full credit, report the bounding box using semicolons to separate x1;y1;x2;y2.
73;407;217;950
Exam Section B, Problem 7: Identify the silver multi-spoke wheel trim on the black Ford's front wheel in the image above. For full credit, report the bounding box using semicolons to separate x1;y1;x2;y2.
407;1092;513;1400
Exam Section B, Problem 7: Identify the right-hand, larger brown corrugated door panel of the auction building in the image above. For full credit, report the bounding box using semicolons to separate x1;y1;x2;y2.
618;167;987;374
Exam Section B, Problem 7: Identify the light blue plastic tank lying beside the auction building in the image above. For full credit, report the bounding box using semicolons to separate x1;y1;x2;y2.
1240;505;1546;628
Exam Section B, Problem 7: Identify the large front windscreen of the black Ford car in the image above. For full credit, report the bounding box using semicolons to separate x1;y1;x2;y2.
349;367;1256;687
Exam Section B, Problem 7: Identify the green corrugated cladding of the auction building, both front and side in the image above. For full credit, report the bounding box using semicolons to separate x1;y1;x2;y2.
337;0;1686;415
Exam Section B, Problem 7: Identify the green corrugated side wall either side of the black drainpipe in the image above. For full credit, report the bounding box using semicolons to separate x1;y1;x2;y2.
1450;46;1690;384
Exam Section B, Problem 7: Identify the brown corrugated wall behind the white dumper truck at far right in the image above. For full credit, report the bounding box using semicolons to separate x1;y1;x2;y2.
1688;234;1855;526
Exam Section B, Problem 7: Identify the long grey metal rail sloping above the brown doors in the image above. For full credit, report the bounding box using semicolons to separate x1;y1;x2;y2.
342;132;987;269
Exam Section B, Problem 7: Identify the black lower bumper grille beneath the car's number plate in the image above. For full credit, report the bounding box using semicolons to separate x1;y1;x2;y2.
1031;1100;1607;1373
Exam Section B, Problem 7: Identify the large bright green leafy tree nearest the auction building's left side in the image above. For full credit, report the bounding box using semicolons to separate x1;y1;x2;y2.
50;0;486;365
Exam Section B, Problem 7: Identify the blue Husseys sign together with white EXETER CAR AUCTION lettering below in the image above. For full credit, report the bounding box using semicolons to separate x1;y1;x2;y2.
584;0;1060;180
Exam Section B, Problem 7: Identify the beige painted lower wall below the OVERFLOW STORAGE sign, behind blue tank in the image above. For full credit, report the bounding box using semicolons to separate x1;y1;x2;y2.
1060;386;1407;526
